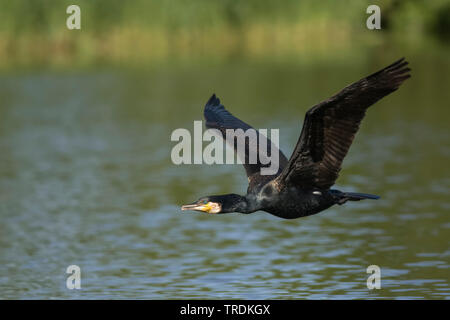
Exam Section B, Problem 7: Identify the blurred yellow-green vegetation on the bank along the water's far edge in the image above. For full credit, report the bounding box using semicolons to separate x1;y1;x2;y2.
0;0;450;67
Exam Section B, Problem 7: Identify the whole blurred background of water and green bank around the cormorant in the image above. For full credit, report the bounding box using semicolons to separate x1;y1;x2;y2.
0;0;450;299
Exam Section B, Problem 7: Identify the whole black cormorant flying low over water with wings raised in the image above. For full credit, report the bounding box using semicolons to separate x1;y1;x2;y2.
181;58;410;219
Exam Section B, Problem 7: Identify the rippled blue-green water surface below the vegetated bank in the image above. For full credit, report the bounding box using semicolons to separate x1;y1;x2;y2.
0;56;450;299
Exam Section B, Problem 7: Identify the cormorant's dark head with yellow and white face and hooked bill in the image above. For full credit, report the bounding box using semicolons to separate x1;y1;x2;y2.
181;194;246;213
